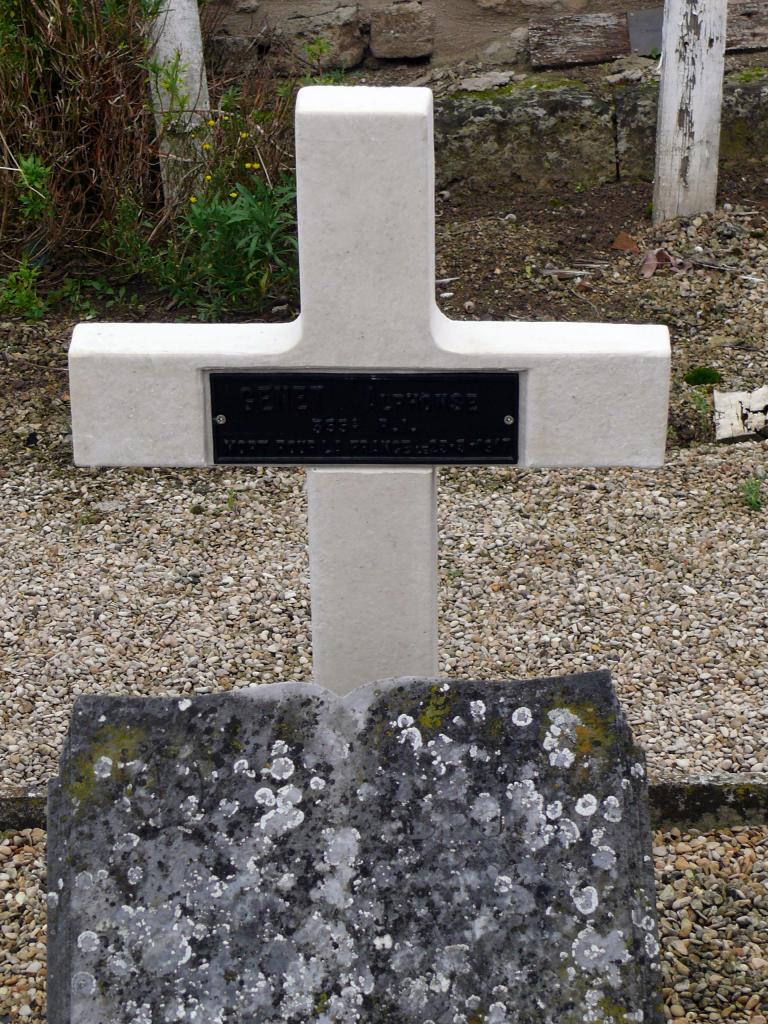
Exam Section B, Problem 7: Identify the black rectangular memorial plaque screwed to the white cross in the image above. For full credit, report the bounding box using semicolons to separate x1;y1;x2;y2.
210;372;519;465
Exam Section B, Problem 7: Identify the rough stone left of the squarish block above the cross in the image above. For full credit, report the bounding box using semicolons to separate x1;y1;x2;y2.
280;4;366;71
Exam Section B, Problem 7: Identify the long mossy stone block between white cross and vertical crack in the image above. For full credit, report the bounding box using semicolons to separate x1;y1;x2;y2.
435;82;616;188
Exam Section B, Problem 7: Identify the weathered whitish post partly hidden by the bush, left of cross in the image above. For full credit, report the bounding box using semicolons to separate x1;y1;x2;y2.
150;0;210;204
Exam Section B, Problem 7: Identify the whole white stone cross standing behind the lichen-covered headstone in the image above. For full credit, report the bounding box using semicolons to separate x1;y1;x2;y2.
70;86;670;692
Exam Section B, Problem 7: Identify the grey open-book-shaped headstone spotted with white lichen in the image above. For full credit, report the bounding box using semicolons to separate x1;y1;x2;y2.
48;672;663;1024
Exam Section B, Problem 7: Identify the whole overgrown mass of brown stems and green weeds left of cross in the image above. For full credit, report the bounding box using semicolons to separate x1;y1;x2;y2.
0;0;296;316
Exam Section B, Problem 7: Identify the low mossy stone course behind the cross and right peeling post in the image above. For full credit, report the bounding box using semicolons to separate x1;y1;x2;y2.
435;69;768;189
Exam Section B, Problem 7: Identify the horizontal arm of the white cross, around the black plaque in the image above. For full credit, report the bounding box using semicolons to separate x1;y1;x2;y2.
70;313;669;466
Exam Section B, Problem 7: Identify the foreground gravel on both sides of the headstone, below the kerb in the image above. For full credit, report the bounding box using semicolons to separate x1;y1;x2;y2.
0;828;768;1024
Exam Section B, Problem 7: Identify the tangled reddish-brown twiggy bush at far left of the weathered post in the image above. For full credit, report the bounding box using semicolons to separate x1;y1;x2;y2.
0;0;160;245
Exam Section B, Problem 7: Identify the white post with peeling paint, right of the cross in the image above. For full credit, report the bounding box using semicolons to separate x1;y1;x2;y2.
653;0;728;224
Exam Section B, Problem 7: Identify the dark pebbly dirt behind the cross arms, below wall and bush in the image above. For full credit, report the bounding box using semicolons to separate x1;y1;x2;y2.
0;168;768;464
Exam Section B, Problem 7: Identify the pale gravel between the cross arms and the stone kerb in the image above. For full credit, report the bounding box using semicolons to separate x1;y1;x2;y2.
0;443;768;792
